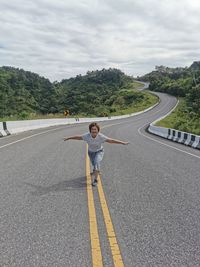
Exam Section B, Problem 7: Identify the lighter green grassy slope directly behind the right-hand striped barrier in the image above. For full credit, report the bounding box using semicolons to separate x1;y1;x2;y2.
156;98;200;135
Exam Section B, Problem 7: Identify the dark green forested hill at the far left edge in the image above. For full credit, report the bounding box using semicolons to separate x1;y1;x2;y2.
0;67;56;117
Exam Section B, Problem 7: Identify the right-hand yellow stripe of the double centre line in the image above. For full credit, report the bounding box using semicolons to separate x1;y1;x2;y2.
98;176;124;267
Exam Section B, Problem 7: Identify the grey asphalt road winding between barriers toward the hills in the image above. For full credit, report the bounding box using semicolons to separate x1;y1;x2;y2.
0;94;200;267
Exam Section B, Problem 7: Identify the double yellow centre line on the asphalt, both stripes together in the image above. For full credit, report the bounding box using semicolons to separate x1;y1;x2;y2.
86;145;124;267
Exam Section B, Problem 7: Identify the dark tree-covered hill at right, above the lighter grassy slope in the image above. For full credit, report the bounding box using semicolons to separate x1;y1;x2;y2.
139;61;200;116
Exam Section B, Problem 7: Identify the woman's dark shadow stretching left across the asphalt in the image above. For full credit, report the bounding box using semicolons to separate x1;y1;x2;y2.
25;176;87;196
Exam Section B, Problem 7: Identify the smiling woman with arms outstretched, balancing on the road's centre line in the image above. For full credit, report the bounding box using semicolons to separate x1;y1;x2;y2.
64;122;129;186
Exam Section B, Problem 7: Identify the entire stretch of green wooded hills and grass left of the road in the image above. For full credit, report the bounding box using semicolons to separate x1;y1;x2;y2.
0;67;157;120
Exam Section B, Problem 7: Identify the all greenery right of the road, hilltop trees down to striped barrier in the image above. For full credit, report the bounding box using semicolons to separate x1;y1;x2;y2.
140;62;200;135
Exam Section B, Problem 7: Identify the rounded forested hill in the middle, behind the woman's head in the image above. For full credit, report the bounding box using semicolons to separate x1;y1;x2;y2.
56;69;133;116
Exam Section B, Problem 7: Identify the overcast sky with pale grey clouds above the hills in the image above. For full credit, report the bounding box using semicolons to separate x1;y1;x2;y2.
0;0;200;81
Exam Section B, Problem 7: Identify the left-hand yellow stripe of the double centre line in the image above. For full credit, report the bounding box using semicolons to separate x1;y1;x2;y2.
86;145;103;267
